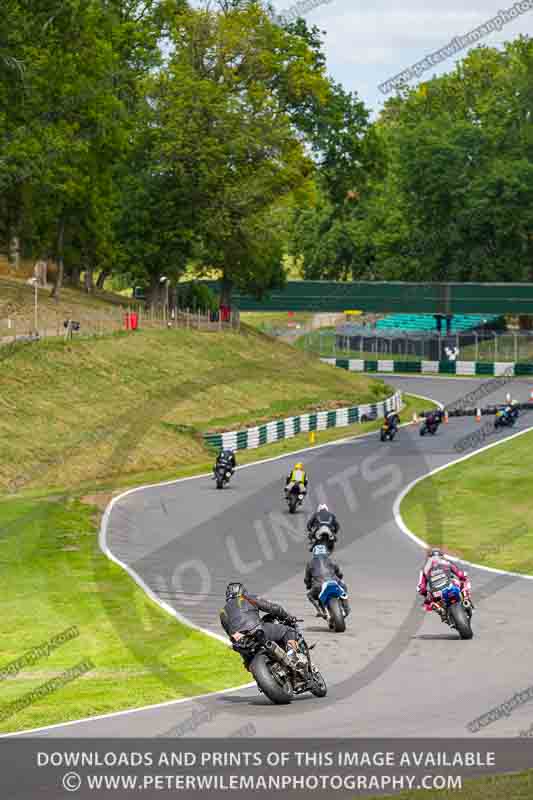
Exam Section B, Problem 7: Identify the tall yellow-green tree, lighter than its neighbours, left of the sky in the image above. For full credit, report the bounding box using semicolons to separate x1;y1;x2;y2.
151;3;327;302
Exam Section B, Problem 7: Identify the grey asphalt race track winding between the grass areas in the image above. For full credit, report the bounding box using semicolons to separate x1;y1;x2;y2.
26;376;533;738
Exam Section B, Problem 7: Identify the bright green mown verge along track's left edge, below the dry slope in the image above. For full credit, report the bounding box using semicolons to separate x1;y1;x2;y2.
0;396;432;733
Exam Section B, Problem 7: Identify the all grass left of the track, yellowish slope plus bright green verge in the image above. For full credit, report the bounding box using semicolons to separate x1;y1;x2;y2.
0;324;432;732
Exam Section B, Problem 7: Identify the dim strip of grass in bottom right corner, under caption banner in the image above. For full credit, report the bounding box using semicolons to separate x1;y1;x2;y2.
370;772;533;800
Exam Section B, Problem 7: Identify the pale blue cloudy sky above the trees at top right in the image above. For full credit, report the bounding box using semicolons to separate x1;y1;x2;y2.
272;0;533;114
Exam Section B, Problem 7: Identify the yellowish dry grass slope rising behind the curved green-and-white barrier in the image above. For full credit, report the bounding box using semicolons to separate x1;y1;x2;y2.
0;329;390;493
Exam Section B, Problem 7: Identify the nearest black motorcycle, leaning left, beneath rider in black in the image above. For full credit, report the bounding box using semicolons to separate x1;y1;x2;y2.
233;614;328;705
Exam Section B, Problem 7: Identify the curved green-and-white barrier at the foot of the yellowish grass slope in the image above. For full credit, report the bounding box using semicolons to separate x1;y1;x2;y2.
204;392;402;450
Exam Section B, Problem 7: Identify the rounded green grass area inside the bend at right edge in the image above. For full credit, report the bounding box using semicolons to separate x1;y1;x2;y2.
400;432;533;574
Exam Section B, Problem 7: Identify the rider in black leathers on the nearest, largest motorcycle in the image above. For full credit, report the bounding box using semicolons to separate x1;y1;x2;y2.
220;581;307;669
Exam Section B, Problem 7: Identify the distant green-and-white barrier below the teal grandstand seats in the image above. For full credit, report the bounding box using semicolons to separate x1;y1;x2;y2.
320;358;533;377
